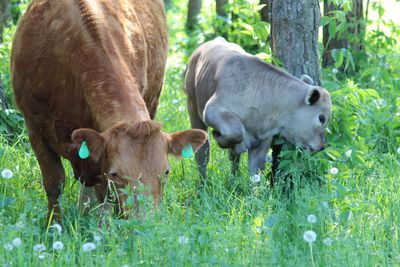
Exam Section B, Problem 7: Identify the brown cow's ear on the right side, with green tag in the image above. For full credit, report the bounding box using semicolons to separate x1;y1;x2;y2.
168;129;207;157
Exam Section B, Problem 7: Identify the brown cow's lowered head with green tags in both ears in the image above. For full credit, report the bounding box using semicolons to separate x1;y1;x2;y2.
72;120;207;211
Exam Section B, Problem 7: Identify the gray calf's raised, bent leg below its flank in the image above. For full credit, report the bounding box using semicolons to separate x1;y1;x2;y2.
204;101;245;148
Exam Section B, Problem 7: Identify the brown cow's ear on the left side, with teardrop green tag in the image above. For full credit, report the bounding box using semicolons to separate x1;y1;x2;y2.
71;128;106;161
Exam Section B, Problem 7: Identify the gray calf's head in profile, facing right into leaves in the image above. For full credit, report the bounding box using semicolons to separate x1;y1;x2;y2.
280;86;332;151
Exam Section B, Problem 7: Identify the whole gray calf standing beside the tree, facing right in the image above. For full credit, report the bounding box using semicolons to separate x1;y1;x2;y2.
186;37;331;178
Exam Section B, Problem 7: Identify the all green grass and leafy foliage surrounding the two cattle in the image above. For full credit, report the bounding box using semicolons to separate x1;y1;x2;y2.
0;0;400;266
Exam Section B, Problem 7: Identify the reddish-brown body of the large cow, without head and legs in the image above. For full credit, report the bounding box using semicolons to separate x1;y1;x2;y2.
11;0;167;156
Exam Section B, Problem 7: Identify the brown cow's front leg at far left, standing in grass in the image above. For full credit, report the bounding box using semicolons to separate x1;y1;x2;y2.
29;133;65;222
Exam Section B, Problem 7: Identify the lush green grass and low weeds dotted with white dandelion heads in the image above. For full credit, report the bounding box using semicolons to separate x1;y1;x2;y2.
0;1;400;266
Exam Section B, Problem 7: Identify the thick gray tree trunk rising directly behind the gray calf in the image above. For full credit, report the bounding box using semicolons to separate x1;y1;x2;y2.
271;0;321;85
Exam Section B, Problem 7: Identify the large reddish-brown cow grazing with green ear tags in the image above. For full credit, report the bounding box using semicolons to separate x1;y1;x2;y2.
11;0;207;222
